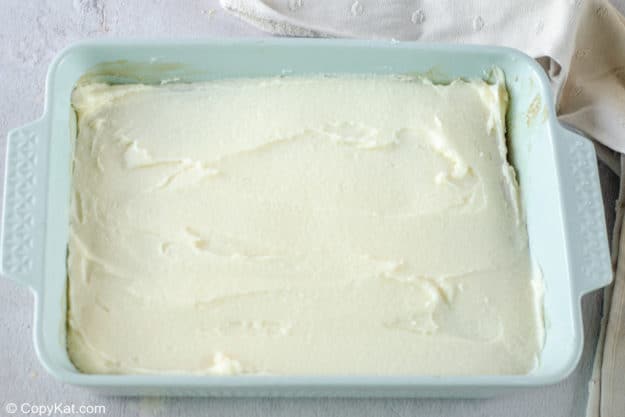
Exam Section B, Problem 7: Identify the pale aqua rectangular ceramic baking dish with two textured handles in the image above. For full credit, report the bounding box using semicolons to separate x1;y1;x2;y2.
1;39;611;397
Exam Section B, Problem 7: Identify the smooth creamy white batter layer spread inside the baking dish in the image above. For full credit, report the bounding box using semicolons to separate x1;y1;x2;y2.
67;75;543;375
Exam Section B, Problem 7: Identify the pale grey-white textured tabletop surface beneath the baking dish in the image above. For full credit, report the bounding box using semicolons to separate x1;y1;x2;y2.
0;0;616;417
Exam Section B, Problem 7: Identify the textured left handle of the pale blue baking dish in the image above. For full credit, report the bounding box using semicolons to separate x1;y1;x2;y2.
0;118;48;290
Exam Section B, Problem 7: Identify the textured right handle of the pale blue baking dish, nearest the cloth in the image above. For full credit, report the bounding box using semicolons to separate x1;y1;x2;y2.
559;125;612;296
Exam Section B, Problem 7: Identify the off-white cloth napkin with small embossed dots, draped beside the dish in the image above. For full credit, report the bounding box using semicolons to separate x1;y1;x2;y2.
220;0;625;417
